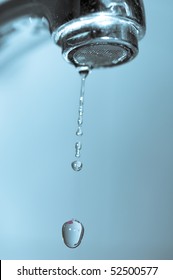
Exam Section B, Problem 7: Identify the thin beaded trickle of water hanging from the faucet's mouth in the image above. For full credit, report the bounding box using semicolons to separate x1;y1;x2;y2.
71;66;89;171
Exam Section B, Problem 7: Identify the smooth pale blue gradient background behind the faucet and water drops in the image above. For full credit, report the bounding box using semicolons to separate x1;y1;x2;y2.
0;0;173;259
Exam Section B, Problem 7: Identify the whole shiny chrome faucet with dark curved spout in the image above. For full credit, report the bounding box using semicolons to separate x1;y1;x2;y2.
0;0;146;69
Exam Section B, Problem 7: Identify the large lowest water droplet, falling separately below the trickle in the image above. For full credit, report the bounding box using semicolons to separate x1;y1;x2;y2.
62;219;84;248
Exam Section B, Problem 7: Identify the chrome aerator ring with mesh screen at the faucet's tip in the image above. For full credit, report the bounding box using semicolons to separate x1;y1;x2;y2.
53;13;138;68
